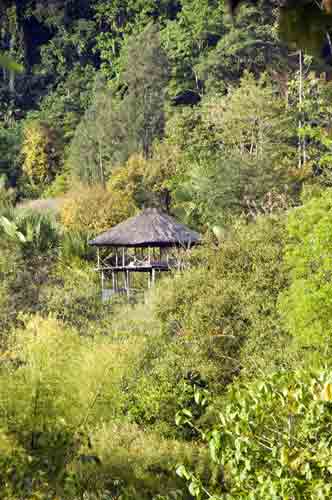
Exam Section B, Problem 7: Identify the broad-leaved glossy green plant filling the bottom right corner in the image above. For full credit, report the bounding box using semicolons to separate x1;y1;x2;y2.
177;368;332;500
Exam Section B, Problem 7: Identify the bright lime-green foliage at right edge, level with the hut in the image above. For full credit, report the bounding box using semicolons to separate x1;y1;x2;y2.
280;189;332;351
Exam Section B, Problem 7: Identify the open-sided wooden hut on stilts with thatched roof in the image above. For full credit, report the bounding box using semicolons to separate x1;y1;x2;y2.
89;208;200;297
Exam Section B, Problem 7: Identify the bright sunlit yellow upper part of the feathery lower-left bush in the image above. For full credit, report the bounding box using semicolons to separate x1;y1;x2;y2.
0;316;139;439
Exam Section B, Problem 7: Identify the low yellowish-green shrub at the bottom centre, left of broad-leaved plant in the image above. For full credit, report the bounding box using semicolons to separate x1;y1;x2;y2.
71;422;207;500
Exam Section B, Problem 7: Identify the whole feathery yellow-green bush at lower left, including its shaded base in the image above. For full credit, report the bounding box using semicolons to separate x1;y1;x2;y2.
0;316;141;498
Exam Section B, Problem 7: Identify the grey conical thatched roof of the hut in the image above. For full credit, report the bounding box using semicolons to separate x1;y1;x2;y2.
89;208;200;247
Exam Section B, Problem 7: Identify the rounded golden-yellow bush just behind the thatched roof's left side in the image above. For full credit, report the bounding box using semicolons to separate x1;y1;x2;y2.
61;185;135;234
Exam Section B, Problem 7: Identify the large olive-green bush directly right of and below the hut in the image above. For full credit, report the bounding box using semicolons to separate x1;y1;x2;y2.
155;213;287;383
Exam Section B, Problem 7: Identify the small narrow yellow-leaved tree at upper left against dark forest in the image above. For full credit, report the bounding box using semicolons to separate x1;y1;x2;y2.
21;120;57;184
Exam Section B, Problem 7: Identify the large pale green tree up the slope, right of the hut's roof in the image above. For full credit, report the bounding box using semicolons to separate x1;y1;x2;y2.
179;74;296;223
